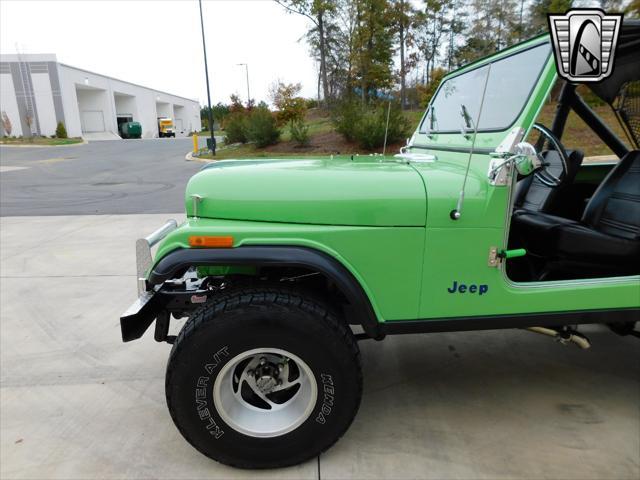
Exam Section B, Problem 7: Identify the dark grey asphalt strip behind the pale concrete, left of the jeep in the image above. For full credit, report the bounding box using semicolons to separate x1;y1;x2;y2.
0;138;202;216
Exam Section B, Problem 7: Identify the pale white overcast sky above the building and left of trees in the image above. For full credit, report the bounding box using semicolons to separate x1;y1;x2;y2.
0;0;317;104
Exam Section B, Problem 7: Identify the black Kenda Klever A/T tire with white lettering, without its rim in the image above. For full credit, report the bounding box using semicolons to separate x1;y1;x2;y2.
165;286;362;468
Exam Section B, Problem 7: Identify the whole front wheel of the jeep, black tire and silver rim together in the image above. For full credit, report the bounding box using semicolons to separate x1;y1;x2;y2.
166;288;362;468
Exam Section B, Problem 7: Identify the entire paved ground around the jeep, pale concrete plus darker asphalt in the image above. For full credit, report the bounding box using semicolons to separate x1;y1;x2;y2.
0;139;640;479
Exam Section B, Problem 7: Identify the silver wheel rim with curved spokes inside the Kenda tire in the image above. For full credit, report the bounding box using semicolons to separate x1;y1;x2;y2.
213;348;318;438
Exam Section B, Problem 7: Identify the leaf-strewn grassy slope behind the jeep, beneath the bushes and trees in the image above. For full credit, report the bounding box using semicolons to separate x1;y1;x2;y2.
194;102;626;160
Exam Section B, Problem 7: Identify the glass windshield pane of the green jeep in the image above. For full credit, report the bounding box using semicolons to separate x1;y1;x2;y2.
420;43;551;133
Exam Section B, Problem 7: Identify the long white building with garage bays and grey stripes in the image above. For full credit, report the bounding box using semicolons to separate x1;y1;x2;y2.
0;54;201;138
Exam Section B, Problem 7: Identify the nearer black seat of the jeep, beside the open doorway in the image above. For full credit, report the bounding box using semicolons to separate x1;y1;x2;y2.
513;150;640;278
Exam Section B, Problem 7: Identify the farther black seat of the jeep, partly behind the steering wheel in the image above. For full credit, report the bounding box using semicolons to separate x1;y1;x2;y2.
514;150;584;213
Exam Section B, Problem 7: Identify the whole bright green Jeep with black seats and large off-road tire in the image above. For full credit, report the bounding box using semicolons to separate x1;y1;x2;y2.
121;26;640;468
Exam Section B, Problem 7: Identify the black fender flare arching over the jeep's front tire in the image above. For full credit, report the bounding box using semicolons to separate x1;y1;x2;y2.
147;245;384;340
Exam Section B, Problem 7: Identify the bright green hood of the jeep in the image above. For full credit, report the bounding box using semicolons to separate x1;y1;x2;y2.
185;157;426;226
